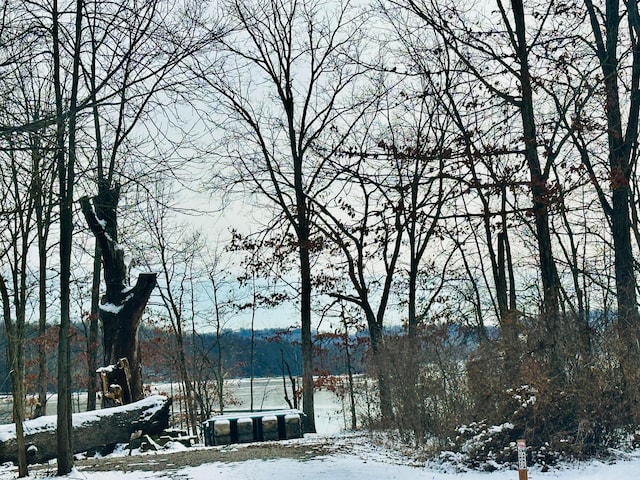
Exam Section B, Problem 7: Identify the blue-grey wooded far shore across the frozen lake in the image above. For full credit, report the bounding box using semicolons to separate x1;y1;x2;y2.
0;323;368;394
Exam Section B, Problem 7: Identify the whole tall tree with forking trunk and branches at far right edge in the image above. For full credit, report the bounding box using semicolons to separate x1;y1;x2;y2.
567;0;640;408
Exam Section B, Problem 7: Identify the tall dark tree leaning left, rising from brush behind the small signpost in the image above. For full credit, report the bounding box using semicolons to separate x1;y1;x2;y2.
397;0;564;382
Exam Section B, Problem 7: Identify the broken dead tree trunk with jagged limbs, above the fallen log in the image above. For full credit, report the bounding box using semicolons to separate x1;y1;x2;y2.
80;193;156;403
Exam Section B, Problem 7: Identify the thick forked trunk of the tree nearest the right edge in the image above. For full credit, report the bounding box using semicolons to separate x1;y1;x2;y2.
584;0;640;412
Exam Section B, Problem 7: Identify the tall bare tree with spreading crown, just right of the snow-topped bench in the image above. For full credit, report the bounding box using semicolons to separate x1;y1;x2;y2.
197;0;376;432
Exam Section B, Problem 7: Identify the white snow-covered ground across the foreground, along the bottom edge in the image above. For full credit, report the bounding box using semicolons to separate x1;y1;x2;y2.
0;437;640;480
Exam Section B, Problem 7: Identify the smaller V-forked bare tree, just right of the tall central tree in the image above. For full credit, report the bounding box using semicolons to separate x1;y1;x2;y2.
316;156;405;420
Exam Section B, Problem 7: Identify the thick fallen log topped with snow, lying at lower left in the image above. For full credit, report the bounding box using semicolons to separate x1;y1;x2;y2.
0;395;171;463
